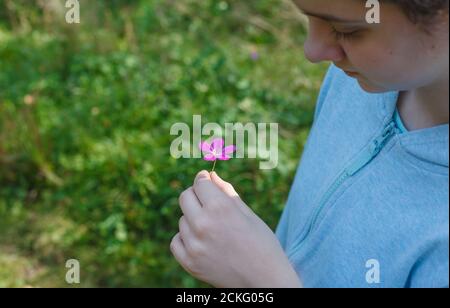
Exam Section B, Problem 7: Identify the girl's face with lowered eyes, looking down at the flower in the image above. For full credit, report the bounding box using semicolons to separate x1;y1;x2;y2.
294;0;449;92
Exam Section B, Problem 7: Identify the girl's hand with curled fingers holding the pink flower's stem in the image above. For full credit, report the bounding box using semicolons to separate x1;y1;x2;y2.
170;171;301;288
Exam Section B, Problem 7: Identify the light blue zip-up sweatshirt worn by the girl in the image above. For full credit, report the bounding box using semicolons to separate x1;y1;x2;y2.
276;66;449;288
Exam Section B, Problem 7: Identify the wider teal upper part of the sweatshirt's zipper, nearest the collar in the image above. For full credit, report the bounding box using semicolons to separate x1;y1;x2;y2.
345;121;395;176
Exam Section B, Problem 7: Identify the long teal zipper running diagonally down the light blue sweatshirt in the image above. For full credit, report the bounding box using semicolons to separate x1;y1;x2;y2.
289;120;396;258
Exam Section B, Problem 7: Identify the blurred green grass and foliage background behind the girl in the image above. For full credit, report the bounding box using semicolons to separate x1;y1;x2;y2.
0;0;326;287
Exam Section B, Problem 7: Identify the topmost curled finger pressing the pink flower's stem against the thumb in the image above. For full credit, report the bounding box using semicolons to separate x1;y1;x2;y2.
194;171;228;206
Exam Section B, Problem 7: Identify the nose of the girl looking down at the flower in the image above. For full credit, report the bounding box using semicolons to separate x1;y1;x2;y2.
304;20;345;63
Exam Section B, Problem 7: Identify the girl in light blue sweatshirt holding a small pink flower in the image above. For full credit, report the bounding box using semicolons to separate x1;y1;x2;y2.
170;0;449;287
